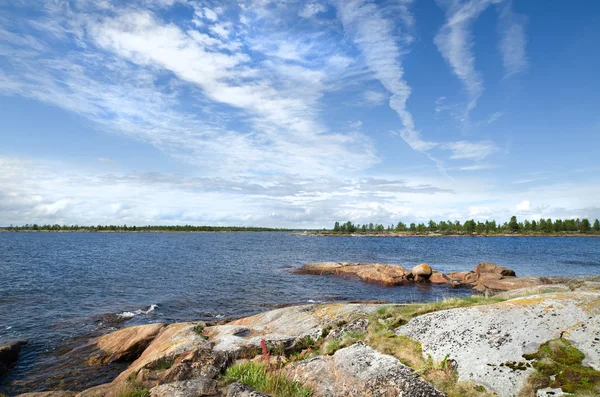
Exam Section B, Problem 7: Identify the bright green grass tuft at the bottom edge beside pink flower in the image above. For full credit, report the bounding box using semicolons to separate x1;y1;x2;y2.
224;362;313;397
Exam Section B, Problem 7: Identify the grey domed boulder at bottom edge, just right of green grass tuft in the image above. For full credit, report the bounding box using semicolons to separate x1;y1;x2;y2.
283;342;445;397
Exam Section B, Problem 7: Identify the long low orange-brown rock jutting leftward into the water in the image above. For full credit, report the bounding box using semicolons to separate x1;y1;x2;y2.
295;262;410;286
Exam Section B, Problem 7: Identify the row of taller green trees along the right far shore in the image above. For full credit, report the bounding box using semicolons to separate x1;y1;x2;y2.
325;216;600;234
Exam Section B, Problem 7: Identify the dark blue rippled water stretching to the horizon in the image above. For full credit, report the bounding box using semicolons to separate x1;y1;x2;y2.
0;233;600;390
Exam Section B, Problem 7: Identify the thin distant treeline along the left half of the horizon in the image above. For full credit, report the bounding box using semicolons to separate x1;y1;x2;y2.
2;223;292;232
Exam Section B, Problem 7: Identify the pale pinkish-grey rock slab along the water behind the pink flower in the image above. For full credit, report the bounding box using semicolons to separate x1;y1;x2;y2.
204;304;383;358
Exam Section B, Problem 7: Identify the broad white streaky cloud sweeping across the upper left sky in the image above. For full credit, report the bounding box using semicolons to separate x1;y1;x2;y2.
0;3;377;175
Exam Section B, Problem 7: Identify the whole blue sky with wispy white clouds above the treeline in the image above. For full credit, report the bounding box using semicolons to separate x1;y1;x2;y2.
0;0;600;228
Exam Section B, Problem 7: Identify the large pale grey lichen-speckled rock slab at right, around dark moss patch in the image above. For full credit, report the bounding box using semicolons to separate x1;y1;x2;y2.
396;291;600;397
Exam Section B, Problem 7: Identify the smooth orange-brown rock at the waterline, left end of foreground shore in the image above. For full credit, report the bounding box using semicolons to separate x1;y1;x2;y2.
87;323;165;365
